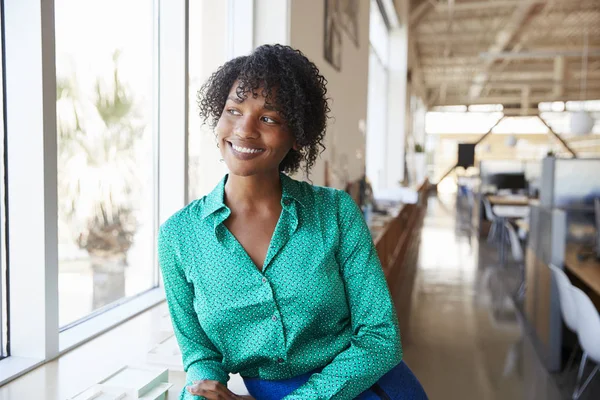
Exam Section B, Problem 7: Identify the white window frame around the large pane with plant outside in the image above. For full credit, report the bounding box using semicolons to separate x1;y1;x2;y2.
0;0;189;385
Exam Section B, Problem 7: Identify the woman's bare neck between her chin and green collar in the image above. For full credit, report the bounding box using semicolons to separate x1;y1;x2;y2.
225;170;282;208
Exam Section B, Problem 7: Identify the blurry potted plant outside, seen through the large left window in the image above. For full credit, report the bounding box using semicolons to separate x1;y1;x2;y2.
57;52;145;309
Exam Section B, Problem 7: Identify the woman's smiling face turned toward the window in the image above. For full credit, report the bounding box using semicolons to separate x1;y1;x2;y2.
216;81;295;176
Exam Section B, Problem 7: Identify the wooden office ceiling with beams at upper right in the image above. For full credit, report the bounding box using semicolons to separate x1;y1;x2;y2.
409;0;600;109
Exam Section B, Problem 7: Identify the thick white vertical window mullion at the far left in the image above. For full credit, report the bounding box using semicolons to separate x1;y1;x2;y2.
4;0;58;360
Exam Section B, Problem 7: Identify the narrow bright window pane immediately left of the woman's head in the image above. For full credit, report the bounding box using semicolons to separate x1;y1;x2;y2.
188;1;229;200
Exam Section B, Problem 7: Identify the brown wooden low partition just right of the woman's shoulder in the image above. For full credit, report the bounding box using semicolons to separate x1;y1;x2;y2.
375;182;430;343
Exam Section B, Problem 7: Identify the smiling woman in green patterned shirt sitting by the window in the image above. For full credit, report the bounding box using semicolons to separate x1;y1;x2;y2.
158;45;426;400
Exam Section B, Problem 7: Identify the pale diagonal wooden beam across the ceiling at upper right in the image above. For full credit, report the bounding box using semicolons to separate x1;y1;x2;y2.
469;0;536;100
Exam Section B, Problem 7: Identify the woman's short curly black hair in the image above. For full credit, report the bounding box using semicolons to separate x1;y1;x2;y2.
198;44;330;176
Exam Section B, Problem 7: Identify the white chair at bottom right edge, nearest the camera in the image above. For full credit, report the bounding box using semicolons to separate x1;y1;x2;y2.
572;286;600;400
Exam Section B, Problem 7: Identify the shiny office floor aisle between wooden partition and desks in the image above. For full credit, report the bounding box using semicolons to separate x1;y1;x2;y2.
404;192;524;400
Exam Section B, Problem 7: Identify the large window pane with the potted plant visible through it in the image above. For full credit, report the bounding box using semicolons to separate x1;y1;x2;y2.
55;0;156;327
